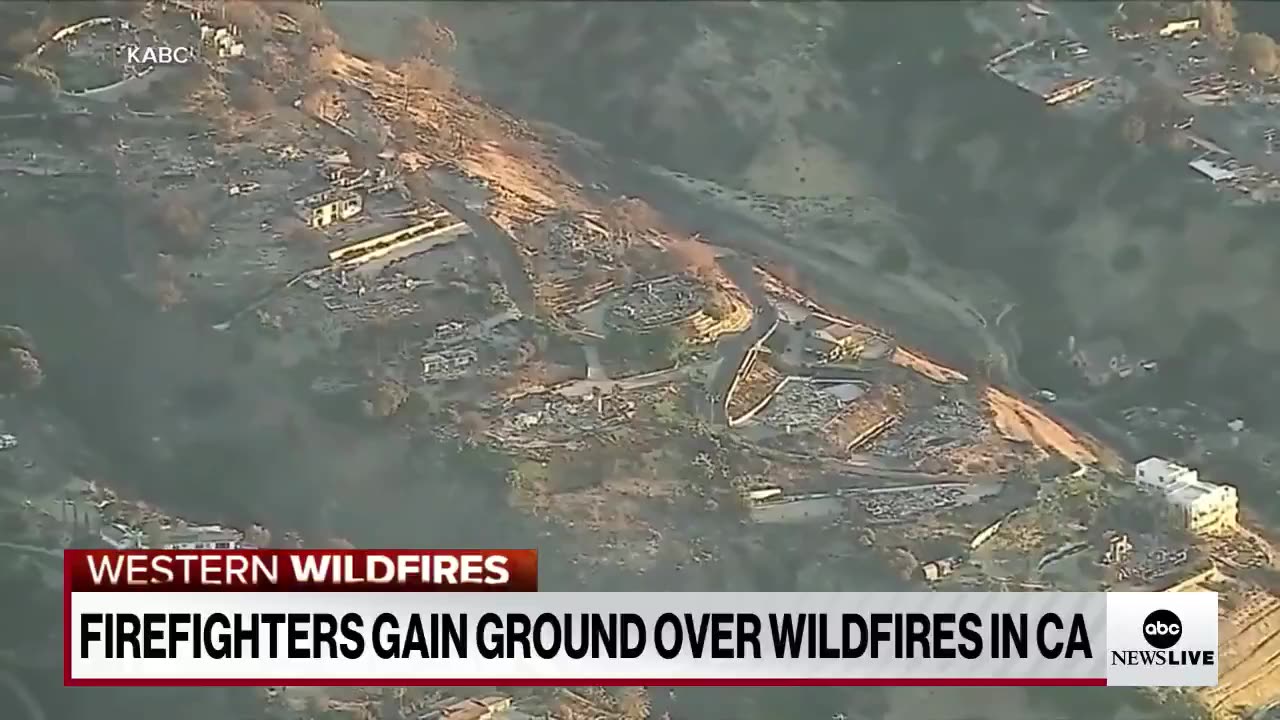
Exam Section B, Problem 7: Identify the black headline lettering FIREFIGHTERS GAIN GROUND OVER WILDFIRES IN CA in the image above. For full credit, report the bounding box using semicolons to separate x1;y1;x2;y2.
76;612;1093;660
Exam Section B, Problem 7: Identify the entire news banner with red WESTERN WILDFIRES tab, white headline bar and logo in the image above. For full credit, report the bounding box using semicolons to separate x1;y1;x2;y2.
64;550;1219;687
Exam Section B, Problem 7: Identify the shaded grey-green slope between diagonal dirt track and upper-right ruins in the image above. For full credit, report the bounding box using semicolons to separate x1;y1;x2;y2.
329;3;1280;419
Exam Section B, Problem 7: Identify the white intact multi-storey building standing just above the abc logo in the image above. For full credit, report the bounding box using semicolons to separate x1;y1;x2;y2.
1134;457;1240;533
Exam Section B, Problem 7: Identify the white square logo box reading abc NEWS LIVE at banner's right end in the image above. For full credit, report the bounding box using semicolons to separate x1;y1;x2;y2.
1107;593;1217;687
